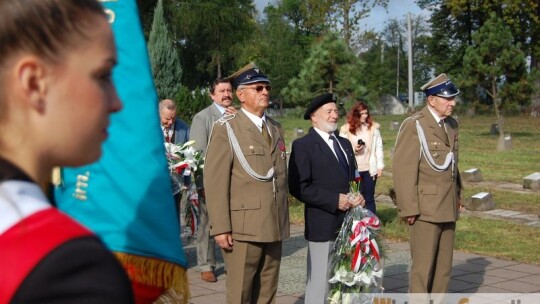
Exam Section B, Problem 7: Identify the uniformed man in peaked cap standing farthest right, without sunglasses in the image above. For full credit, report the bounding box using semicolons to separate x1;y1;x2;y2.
393;74;462;294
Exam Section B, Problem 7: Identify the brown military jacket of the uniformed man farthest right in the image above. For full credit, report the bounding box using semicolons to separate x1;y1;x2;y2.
392;106;462;223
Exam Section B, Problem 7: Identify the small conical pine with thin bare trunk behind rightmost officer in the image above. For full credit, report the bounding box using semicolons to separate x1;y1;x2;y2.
462;13;530;150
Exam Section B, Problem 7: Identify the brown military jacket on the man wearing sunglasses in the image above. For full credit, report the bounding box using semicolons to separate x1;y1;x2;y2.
204;111;289;242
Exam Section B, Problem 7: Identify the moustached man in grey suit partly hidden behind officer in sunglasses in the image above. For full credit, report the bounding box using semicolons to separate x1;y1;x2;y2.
189;78;236;283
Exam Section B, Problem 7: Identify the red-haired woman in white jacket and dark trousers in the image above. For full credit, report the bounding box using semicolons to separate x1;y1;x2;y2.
339;101;384;214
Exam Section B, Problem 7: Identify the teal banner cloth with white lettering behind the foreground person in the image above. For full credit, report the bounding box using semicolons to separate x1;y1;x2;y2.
55;0;187;267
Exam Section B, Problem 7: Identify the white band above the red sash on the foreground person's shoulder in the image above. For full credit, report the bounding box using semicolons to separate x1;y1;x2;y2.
0;180;52;234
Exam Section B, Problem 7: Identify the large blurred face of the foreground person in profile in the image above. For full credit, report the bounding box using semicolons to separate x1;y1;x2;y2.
43;16;122;166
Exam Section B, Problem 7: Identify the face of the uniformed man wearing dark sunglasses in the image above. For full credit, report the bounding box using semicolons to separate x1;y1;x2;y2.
236;82;272;117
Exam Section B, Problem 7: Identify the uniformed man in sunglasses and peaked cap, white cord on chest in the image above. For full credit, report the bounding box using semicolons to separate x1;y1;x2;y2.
204;64;289;303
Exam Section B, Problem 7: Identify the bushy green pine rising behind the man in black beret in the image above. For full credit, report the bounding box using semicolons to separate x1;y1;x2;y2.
281;33;365;106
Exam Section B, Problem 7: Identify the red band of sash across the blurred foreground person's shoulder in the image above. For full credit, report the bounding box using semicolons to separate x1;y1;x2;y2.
0;208;92;303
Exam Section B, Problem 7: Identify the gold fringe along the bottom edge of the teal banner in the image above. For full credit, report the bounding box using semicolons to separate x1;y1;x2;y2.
114;252;191;303
